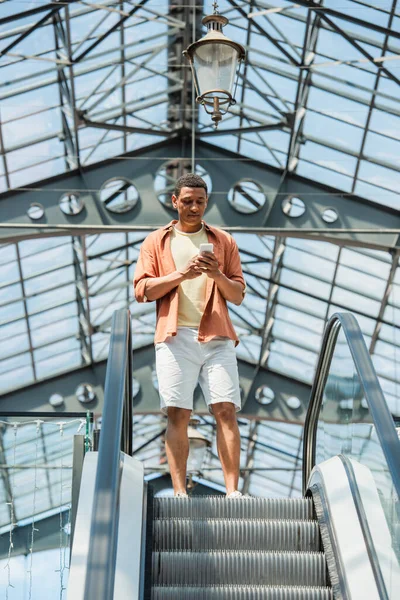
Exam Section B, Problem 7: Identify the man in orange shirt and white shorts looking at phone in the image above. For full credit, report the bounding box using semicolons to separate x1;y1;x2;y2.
134;174;245;498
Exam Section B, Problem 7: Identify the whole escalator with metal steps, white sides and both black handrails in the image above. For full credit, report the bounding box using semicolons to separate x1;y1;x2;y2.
68;310;400;600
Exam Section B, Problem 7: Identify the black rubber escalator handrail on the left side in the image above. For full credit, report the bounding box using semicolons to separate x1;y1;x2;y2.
84;309;132;600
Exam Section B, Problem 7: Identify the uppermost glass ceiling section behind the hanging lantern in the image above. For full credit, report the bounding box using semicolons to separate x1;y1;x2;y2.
0;0;400;208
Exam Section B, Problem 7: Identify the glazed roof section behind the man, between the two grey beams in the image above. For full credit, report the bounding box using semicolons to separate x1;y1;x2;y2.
0;233;400;414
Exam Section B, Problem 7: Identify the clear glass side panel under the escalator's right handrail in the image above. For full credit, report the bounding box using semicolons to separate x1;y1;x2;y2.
316;329;400;598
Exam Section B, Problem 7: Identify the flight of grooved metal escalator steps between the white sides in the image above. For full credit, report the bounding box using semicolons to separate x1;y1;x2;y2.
150;496;332;600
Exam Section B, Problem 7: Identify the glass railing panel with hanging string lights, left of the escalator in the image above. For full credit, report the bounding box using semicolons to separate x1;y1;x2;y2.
0;413;91;600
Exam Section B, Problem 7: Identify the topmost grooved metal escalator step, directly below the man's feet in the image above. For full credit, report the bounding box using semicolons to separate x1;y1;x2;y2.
154;496;314;521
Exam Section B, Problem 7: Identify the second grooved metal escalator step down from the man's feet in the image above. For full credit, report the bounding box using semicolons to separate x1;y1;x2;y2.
153;519;320;551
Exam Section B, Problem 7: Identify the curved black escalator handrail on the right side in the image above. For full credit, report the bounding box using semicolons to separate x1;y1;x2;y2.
303;313;400;497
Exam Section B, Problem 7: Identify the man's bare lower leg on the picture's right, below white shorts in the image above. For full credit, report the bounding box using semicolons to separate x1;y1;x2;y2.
212;402;240;494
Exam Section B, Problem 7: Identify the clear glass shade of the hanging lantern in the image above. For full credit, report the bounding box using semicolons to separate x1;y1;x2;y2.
193;40;239;102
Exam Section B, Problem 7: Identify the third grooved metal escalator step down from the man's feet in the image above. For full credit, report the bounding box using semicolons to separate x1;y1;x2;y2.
152;551;326;586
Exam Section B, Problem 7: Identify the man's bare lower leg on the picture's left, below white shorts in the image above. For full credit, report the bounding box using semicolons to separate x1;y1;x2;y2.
165;407;191;494
